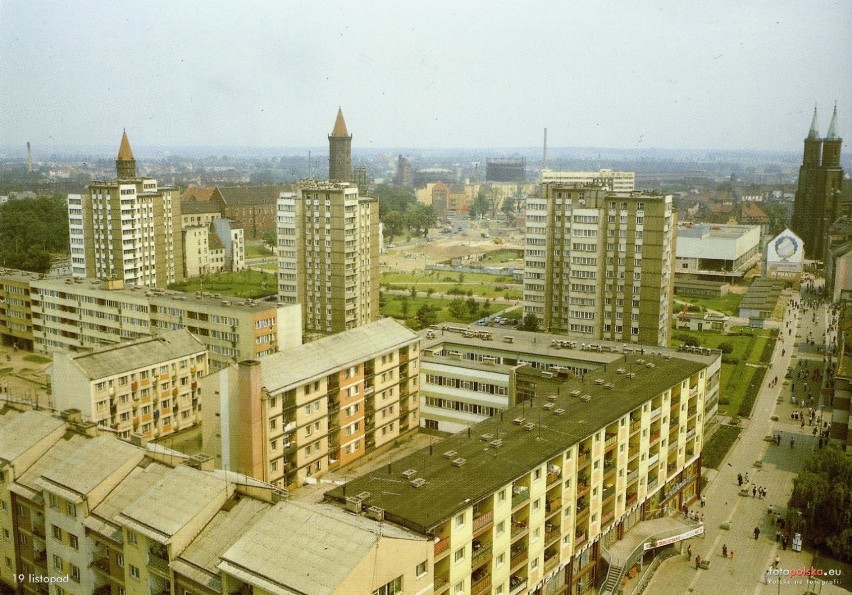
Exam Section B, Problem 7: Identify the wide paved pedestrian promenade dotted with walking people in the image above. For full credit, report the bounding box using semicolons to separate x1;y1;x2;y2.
646;286;847;595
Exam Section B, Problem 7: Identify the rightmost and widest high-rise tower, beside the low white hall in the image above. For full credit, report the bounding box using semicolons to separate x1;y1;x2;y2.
524;183;677;346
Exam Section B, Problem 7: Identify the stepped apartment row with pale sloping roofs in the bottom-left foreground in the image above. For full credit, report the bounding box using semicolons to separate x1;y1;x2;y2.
0;408;433;595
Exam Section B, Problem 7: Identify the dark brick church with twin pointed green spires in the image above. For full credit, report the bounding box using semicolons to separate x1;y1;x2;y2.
790;106;844;260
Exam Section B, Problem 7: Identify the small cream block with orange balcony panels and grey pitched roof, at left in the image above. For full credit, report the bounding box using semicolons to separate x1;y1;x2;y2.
50;329;209;439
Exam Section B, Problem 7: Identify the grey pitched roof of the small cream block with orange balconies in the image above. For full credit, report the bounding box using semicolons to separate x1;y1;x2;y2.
65;329;207;379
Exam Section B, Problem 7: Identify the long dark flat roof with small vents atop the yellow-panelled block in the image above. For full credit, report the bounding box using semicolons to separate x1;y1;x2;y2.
326;353;709;533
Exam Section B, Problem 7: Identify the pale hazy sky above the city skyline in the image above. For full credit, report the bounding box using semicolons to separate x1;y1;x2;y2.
0;0;852;151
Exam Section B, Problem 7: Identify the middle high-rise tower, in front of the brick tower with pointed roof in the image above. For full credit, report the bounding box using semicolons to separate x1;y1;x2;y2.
278;180;380;334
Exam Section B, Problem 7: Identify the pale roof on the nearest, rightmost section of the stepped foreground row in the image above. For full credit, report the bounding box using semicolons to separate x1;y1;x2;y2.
218;502;422;595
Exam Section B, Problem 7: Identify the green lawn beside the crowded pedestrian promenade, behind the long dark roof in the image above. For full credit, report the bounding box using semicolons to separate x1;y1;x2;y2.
672;327;776;417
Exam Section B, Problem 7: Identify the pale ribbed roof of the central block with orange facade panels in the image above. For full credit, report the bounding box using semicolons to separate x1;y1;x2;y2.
260;318;419;393
